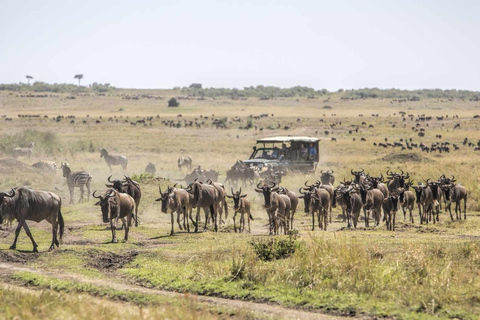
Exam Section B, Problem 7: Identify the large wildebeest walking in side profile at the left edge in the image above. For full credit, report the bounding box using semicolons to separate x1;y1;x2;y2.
0;187;65;252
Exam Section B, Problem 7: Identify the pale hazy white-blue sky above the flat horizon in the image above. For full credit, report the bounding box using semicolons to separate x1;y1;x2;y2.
0;0;480;91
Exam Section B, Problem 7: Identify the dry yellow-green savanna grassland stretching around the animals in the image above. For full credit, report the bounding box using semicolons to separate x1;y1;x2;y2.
0;90;480;319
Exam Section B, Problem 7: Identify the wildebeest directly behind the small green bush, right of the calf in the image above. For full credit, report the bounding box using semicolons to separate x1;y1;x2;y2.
255;183;291;234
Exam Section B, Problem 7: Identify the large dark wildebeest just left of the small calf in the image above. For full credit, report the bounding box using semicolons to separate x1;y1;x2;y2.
187;181;219;232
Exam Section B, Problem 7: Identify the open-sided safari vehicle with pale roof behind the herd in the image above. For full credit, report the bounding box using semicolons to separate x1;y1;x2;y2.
243;137;320;172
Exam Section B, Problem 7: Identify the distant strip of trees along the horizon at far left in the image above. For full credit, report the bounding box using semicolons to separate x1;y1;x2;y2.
0;81;115;93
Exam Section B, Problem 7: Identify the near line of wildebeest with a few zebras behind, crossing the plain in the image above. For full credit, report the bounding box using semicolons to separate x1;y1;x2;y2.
0;149;467;251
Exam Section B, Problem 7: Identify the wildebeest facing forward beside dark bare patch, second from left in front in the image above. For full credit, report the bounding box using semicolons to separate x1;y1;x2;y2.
93;189;135;243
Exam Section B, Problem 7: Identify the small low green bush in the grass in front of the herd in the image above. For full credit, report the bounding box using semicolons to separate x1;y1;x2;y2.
250;233;299;261
